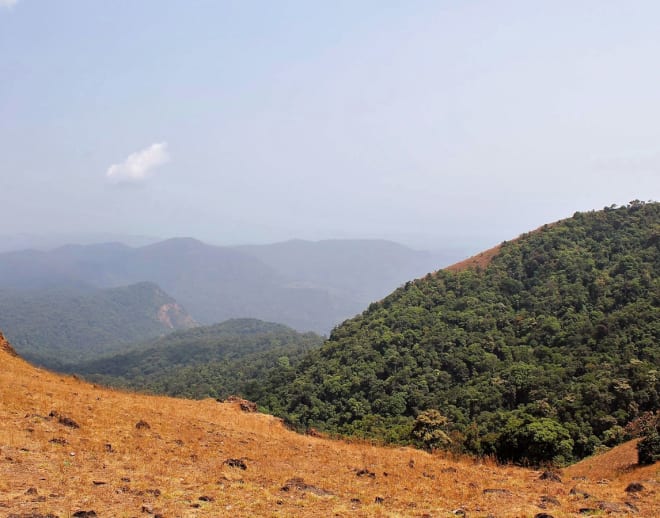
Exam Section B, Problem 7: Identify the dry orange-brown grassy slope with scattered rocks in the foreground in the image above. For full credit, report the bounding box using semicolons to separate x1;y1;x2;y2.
0;339;660;517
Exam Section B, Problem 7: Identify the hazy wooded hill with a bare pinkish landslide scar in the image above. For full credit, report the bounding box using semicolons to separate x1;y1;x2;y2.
0;282;196;366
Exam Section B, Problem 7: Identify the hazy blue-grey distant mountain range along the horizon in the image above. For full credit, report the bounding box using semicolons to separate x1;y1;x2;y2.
0;238;439;334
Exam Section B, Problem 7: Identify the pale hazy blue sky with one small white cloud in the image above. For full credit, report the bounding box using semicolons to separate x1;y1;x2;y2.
0;0;660;248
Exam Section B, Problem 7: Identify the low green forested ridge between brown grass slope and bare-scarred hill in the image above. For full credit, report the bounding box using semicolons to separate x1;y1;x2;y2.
65;319;323;400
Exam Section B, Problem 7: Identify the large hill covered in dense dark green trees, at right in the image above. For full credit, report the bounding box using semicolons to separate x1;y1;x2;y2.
262;201;660;462
